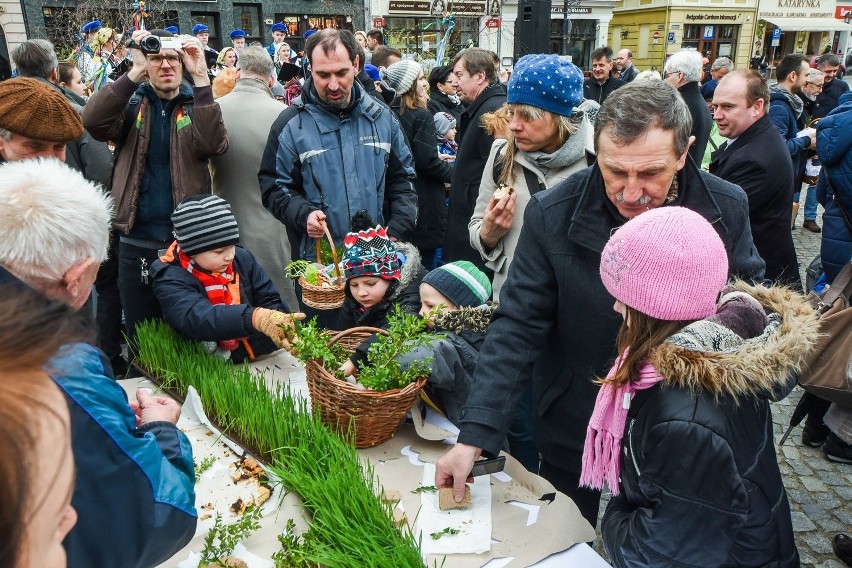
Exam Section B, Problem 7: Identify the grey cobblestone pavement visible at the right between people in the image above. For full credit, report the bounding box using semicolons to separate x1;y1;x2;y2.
594;203;852;568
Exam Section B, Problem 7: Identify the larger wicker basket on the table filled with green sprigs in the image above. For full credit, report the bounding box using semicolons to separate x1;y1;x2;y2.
305;327;426;448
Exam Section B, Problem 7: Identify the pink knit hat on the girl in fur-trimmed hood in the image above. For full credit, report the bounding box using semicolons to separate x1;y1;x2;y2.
601;207;728;321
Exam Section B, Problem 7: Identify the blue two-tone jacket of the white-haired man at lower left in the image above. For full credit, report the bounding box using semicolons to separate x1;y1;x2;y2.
50;344;198;568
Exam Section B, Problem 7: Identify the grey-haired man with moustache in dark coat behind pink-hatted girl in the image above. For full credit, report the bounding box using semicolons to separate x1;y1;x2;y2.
435;81;764;525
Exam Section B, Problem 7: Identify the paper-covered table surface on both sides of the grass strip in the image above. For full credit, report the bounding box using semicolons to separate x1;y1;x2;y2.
121;351;608;568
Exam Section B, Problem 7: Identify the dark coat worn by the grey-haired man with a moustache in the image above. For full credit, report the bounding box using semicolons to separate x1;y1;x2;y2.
458;162;764;473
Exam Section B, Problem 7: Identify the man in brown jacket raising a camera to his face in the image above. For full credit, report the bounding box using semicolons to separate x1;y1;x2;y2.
83;30;228;352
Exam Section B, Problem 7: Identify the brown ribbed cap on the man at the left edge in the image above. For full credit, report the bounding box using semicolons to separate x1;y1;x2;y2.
0;77;83;142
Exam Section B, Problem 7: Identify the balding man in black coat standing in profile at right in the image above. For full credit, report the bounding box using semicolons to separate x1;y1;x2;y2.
710;70;802;290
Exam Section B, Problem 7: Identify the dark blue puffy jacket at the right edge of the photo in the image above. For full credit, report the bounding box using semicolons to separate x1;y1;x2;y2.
817;92;852;282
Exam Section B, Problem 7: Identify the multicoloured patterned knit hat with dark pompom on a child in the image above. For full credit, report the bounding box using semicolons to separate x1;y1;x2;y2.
343;225;402;280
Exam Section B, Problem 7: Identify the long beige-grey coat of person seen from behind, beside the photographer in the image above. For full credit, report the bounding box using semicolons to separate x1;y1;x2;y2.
210;79;299;311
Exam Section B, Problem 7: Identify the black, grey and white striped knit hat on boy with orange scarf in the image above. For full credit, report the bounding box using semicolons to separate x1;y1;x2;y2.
172;195;240;256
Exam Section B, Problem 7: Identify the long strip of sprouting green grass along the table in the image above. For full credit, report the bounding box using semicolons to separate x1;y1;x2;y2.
137;322;423;568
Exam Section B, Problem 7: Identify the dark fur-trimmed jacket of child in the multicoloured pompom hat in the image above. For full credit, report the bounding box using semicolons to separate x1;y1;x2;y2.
337;243;426;363
